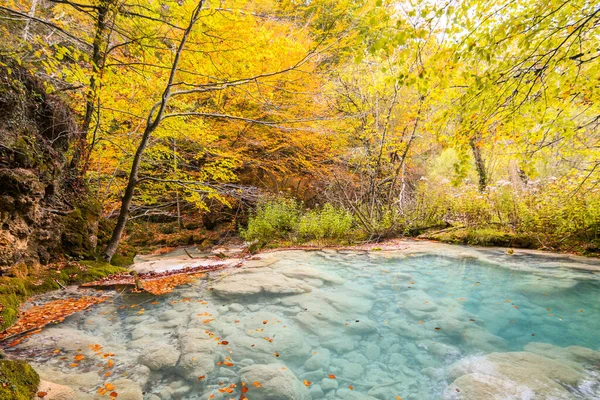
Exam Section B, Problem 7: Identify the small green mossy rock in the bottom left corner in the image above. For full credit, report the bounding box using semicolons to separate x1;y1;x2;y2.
0;360;40;400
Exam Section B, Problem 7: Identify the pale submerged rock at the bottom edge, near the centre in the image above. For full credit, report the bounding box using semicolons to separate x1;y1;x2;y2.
240;364;311;400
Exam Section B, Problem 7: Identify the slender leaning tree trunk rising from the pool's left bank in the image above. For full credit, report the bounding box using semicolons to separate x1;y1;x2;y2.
102;0;204;262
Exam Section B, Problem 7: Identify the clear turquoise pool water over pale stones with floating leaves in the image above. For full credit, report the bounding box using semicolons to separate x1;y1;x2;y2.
8;251;600;400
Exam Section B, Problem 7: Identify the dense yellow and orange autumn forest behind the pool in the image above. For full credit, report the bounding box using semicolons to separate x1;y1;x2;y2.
0;0;600;264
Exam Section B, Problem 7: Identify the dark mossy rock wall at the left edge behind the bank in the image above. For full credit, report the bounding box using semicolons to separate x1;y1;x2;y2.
0;57;100;274
